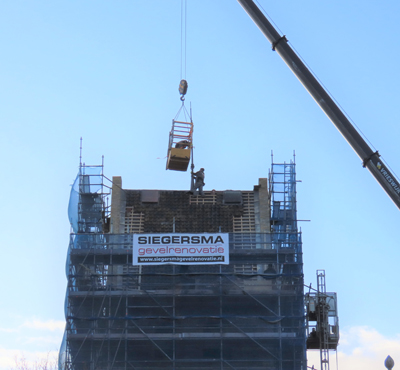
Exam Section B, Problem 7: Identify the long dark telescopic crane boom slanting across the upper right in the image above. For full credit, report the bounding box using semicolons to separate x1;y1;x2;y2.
238;0;400;209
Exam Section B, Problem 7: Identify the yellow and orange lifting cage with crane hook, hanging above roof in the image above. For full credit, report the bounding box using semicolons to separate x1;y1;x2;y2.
166;80;193;171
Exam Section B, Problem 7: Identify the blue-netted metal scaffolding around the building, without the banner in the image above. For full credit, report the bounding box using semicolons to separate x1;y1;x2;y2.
59;160;306;370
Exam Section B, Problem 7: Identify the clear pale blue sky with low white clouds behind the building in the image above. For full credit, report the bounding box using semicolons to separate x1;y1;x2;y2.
0;0;400;370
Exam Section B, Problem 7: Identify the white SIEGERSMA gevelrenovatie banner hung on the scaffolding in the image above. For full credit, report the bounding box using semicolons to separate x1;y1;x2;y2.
132;233;229;266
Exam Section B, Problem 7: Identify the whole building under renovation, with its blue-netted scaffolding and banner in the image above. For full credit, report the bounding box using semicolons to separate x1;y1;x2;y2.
60;158;306;370
